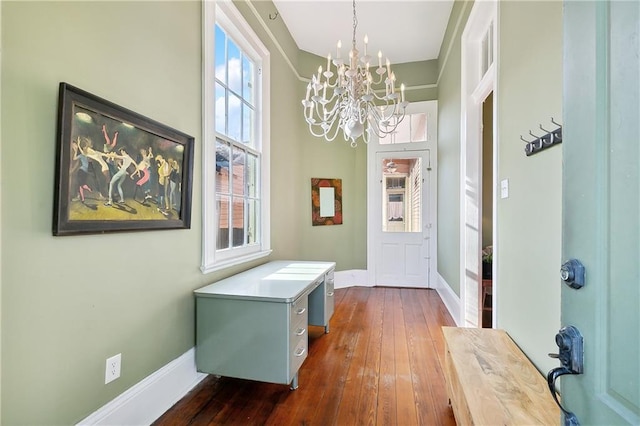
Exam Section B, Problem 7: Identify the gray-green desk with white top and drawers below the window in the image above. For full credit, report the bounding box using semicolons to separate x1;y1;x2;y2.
194;261;335;389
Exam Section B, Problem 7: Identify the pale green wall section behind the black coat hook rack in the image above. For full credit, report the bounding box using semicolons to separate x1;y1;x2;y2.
496;1;562;372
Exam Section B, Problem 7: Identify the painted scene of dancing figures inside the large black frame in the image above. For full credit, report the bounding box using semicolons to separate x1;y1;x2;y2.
64;110;184;220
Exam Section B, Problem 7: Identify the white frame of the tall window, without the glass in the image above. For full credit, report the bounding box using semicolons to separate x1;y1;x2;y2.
200;1;271;274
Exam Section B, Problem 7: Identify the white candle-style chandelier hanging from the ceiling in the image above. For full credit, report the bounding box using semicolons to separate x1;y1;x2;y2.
302;0;409;147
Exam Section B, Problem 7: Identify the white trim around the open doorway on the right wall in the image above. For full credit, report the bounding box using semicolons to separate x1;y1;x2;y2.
460;1;499;327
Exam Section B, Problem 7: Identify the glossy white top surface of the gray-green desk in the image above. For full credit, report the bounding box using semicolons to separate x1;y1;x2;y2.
194;261;336;303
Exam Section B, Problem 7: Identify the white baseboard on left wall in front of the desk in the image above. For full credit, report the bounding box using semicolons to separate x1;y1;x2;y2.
78;348;207;426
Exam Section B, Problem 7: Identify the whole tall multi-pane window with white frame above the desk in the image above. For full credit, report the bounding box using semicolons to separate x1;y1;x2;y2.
202;2;270;272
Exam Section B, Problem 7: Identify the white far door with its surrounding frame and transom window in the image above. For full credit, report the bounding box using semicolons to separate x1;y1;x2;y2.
367;101;438;287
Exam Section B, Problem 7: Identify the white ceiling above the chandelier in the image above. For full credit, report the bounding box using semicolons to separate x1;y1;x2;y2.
271;0;453;63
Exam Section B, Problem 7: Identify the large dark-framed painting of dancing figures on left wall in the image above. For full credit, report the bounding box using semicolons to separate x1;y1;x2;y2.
53;83;194;235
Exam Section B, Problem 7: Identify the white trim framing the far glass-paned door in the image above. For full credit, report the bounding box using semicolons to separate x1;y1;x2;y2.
367;100;438;288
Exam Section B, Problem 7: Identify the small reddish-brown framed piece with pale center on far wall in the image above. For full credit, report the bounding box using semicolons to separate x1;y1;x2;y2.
311;178;342;226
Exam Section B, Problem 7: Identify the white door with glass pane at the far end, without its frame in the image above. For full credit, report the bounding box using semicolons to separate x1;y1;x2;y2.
371;150;431;287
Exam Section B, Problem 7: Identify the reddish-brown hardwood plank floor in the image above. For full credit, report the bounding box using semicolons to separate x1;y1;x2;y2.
154;287;455;426
